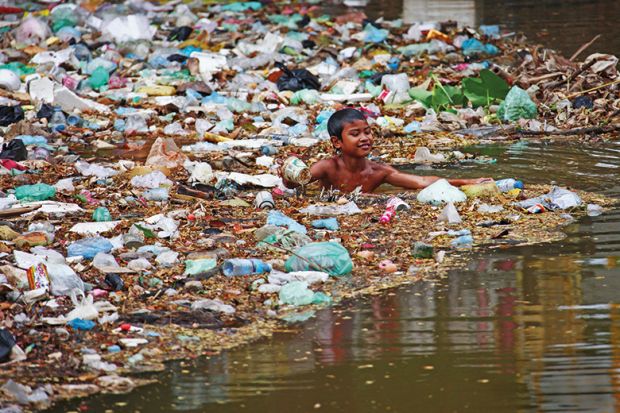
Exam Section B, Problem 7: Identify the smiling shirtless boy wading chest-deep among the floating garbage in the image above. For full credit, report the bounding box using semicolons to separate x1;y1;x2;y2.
284;108;492;192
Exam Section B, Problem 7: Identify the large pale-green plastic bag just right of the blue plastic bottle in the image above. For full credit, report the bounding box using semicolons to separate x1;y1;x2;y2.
284;242;353;276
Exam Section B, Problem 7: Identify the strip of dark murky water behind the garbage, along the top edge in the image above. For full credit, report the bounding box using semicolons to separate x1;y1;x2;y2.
364;0;620;59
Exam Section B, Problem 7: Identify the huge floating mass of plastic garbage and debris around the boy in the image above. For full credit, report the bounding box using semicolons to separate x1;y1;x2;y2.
0;0;617;411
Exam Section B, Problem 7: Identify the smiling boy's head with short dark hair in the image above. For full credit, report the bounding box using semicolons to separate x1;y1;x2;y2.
327;108;373;157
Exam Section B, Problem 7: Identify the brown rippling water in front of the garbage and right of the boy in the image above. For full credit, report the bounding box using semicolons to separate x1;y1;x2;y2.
50;139;620;412
